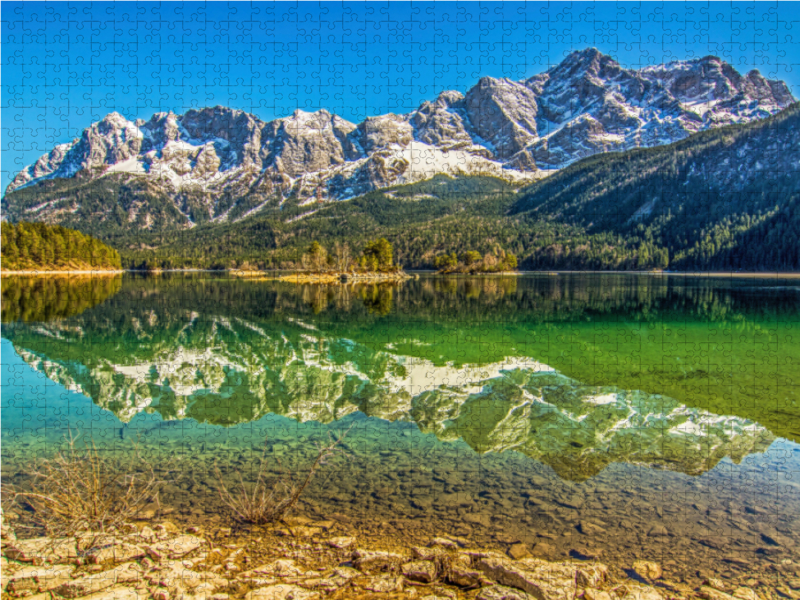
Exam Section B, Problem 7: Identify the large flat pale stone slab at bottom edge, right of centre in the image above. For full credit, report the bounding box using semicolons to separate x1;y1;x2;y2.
477;557;576;600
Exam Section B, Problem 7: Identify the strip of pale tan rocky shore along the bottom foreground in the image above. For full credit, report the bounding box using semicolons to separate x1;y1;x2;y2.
1;517;788;600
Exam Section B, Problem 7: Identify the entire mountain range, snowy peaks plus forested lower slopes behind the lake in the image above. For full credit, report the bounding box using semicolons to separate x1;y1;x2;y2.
2;49;800;270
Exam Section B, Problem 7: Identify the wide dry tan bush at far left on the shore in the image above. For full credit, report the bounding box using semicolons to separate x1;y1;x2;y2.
14;433;163;537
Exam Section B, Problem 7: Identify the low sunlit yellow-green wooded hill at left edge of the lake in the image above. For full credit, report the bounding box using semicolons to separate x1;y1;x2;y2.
1;222;122;271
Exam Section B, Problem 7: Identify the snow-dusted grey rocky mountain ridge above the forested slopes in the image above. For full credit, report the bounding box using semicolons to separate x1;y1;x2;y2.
5;48;794;228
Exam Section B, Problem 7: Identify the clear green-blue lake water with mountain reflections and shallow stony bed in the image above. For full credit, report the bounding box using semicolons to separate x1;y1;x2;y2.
2;273;800;582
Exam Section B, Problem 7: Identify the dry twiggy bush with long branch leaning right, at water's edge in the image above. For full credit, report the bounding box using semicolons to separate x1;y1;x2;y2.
215;426;352;525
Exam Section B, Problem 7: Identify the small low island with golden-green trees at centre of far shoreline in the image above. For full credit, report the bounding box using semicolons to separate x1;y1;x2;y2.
231;238;411;284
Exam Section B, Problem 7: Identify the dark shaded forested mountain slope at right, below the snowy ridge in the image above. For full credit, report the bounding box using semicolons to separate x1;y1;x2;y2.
510;104;800;269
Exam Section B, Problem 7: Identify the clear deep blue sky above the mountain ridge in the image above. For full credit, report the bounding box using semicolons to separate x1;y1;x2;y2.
0;1;800;190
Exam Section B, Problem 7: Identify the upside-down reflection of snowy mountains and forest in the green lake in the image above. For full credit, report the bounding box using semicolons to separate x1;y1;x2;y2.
3;276;800;481
